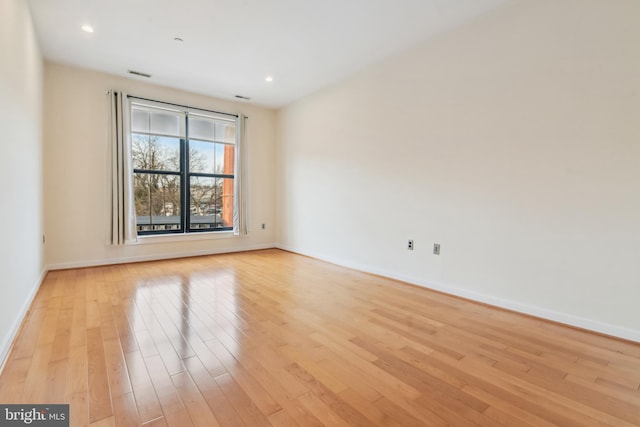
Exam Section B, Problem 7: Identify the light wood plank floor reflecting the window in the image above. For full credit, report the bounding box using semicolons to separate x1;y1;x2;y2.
0;250;640;427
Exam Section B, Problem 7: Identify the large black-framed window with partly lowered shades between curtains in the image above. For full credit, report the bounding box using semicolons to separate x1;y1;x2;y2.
131;98;236;235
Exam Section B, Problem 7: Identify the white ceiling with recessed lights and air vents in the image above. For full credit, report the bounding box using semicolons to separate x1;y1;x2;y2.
29;0;507;107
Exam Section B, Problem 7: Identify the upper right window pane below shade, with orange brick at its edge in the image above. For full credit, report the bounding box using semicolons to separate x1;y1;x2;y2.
189;140;235;175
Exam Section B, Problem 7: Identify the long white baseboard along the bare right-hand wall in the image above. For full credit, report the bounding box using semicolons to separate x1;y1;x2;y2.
276;244;640;342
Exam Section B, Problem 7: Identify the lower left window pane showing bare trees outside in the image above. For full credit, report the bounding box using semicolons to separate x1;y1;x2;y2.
133;173;181;231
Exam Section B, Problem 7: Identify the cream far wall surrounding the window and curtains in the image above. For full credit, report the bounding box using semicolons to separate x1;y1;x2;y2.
44;62;275;268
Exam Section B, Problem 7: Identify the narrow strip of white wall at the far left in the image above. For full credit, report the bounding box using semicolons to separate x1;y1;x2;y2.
0;0;43;363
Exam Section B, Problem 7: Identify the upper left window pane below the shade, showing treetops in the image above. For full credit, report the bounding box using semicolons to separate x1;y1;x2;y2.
131;133;180;172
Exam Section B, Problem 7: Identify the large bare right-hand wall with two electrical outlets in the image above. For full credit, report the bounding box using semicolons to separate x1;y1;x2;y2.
277;0;640;341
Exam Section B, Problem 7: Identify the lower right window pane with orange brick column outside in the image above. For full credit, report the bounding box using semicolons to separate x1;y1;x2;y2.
189;177;233;230
